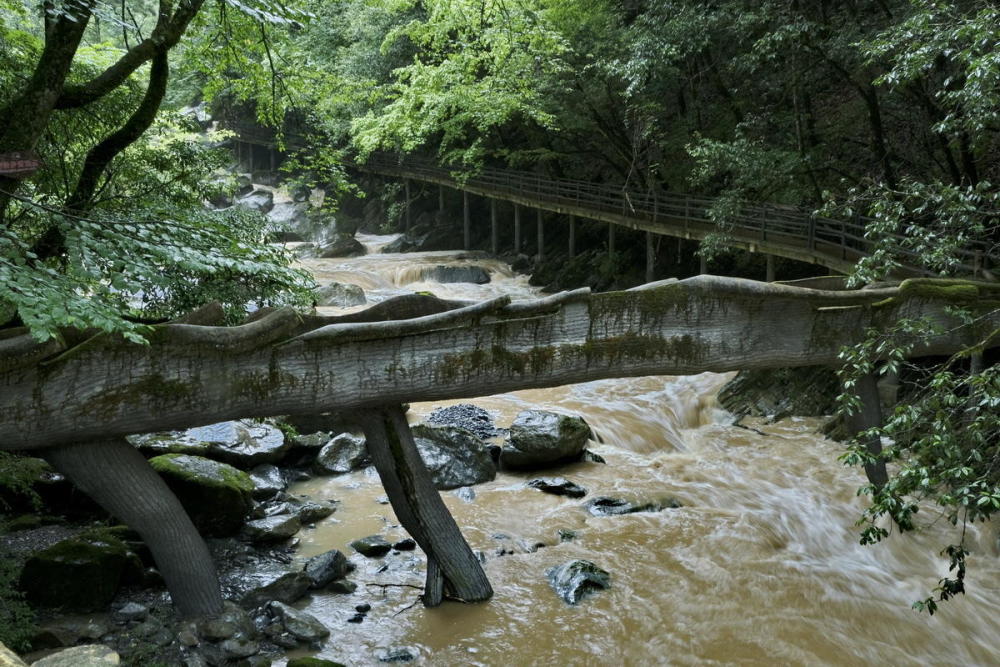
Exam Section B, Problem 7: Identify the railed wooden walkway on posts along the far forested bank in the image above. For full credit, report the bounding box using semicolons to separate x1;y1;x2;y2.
229;135;990;282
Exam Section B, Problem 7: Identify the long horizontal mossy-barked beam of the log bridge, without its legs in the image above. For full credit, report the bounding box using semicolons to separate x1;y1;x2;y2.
0;276;1000;450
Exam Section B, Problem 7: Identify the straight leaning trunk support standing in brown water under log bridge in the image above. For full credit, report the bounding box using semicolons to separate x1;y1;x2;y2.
361;405;493;607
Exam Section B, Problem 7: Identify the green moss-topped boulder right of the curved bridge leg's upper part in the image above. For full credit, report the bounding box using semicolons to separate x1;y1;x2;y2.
149;454;254;537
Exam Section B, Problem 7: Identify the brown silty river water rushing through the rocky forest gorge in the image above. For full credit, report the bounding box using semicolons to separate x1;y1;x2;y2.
282;232;1000;665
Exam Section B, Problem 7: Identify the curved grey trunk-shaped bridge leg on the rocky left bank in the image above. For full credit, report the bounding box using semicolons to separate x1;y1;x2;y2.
44;439;222;618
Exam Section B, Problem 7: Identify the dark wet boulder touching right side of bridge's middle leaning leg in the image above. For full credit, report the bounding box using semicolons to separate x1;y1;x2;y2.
411;424;497;490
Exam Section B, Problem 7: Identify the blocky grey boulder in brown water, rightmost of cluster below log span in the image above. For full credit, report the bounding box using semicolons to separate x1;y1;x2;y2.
500;410;591;468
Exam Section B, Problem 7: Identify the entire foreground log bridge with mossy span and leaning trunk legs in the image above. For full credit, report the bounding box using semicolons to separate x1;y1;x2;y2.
0;275;1000;616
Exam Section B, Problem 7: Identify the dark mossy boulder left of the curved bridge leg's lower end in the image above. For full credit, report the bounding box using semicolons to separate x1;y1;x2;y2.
20;528;142;612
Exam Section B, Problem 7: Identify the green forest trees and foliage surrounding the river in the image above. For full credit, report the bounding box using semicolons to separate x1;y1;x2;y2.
0;0;1000;611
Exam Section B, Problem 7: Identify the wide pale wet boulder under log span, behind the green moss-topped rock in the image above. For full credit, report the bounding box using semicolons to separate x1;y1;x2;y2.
129;420;290;469
